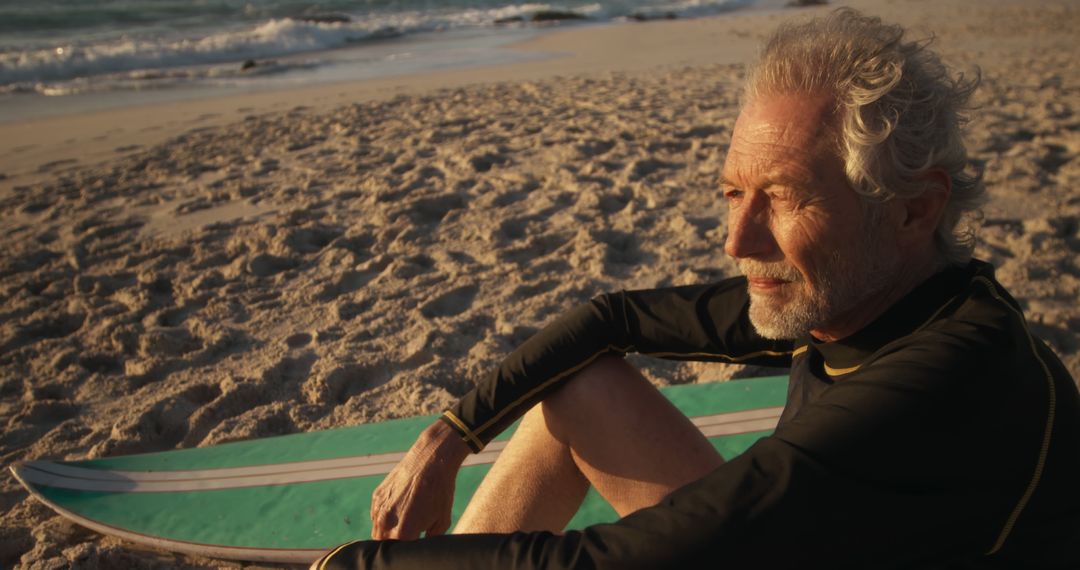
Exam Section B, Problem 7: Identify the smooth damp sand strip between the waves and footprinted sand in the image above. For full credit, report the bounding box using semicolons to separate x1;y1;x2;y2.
0;0;786;196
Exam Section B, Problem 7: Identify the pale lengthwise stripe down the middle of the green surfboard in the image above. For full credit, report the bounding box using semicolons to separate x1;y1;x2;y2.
13;407;783;492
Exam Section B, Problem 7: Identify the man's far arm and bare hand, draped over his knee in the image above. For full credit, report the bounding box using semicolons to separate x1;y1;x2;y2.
372;279;791;540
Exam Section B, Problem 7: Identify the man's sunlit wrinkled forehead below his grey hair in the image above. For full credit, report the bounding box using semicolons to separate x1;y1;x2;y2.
724;94;839;184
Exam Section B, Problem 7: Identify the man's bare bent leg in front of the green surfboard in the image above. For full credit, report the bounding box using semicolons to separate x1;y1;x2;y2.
455;357;724;533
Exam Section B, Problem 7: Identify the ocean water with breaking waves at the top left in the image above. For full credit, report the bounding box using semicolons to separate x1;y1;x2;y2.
0;0;754;117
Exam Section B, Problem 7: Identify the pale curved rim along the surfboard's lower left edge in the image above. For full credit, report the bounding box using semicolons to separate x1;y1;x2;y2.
12;466;328;564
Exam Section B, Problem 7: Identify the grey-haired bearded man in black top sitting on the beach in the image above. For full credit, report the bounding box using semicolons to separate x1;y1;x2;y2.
315;10;1080;569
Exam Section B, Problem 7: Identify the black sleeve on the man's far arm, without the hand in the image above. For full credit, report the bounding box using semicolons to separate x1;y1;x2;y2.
443;277;793;451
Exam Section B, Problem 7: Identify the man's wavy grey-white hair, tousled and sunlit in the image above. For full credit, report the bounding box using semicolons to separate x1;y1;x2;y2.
744;9;986;263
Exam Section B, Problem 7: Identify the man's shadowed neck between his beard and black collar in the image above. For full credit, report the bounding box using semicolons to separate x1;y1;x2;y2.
810;255;944;342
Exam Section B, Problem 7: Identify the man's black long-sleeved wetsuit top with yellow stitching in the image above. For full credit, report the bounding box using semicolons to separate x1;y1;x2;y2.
317;261;1080;570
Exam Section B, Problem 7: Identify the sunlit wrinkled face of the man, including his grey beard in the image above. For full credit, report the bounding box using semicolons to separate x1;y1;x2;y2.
723;94;892;338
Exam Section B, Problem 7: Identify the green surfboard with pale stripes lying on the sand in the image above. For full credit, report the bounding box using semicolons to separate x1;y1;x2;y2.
11;377;787;564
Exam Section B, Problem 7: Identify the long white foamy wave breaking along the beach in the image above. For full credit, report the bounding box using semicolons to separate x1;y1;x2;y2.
0;0;750;93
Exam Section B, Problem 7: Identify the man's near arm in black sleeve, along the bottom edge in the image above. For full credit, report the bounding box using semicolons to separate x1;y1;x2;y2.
327;354;1044;570
